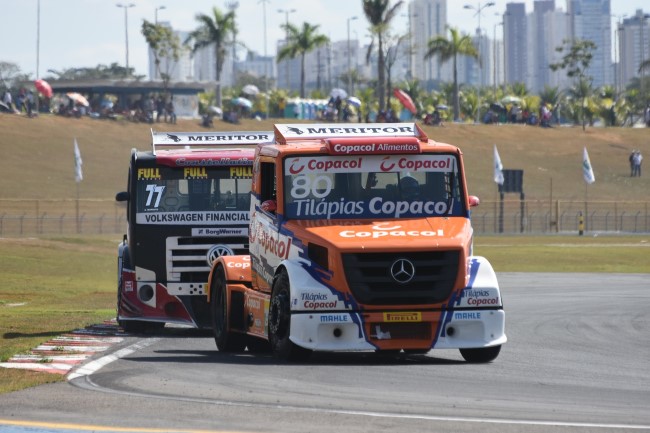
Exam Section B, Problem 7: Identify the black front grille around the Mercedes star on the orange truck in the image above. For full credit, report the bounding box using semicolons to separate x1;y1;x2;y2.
342;250;460;305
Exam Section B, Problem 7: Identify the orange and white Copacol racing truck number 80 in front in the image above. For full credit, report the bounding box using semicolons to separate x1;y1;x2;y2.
208;123;507;362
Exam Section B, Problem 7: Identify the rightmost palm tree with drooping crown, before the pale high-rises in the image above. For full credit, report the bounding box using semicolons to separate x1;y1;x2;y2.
424;27;479;121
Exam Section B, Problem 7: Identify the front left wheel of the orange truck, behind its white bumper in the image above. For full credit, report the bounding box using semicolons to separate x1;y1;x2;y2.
269;271;311;361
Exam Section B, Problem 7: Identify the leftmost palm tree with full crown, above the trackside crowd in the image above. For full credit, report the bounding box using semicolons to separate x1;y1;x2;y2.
185;6;237;107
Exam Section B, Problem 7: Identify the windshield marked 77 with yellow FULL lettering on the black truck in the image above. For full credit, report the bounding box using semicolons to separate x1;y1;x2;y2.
135;167;252;224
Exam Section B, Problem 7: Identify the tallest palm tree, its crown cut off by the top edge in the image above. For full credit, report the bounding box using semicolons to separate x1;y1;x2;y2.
363;0;404;111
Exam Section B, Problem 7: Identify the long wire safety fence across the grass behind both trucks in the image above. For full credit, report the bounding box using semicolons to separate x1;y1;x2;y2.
0;199;650;237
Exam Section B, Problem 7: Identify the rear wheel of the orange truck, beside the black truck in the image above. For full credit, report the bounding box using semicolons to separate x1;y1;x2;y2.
210;266;246;352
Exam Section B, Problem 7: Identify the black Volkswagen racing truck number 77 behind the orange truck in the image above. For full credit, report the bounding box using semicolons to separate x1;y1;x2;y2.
116;131;273;332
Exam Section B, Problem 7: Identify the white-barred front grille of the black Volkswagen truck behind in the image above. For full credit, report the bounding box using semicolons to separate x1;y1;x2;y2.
167;236;248;283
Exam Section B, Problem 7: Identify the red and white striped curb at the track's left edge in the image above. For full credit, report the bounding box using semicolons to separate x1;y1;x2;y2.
0;320;127;374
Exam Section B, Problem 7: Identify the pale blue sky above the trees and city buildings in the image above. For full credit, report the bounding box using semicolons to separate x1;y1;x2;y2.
0;0;650;77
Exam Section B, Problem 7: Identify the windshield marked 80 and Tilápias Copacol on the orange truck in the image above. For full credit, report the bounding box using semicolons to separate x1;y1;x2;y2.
284;154;464;220
